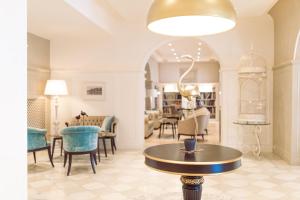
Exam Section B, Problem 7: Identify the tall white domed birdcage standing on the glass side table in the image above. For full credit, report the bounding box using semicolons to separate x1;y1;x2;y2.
239;51;267;122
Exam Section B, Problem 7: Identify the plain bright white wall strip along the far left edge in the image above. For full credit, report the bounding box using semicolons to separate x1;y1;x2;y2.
0;0;27;200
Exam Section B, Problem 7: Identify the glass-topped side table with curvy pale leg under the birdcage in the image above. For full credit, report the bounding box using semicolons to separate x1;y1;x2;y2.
233;121;270;158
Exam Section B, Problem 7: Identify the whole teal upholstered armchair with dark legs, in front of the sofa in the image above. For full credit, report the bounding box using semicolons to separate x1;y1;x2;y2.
61;126;100;176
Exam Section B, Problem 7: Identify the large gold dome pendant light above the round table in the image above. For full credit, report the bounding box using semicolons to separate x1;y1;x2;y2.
147;0;236;36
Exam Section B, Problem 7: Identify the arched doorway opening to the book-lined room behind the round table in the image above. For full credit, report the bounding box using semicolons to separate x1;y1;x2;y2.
144;38;221;144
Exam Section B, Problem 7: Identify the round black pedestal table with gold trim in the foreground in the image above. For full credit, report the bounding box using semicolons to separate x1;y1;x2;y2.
144;144;242;200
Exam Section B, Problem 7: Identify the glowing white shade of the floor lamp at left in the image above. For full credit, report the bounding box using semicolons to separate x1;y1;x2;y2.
45;80;68;96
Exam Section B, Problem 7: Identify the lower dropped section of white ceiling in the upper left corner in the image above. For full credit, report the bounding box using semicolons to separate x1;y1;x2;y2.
27;0;105;39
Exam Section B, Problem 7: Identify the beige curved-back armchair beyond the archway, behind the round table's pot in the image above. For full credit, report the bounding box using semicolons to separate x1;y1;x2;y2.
178;115;209;140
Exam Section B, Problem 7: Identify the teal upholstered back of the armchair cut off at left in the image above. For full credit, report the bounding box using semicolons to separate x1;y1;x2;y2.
27;127;47;150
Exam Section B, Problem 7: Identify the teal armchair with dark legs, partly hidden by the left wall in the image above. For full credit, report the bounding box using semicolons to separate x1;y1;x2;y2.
27;127;54;167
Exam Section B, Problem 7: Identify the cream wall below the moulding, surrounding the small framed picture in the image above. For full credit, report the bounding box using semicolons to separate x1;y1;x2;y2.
51;70;145;149
